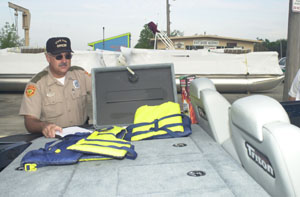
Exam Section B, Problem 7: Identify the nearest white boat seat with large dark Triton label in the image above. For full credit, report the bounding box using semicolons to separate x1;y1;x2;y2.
230;95;300;196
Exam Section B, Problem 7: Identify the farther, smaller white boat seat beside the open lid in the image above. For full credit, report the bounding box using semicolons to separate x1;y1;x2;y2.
190;78;239;162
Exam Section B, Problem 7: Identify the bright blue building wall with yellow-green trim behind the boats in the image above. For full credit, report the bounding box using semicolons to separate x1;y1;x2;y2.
88;33;131;51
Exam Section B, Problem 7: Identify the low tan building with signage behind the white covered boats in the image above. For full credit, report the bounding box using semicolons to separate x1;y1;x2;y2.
151;35;261;52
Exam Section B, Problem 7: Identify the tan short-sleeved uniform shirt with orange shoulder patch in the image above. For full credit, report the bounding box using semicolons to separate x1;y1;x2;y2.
19;66;92;127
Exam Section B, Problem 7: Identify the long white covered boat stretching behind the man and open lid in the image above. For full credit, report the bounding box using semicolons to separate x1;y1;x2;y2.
0;47;284;92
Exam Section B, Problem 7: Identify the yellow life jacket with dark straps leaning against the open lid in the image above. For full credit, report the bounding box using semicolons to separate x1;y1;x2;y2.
125;101;191;141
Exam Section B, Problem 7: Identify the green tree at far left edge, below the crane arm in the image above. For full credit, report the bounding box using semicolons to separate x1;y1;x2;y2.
0;22;24;49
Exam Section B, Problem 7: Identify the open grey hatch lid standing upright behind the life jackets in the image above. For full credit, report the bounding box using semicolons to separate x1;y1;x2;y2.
92;63;177;128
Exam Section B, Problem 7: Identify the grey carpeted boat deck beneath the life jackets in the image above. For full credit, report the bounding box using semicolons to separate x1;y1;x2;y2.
0;125;269;197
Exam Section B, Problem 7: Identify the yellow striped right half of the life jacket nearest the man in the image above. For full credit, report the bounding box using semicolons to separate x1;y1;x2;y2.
67;126;137;161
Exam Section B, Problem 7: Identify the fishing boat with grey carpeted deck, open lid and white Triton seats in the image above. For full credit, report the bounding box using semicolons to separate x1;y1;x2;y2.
0;64;300;196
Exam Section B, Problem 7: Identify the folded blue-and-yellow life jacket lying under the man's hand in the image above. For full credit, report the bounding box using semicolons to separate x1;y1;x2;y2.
20;127;137;171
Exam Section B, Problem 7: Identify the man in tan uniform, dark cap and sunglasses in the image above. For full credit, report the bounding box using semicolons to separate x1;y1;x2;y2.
19;37;92;137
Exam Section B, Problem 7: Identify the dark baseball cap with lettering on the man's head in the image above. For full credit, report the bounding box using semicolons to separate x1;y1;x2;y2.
46;37;73;55
